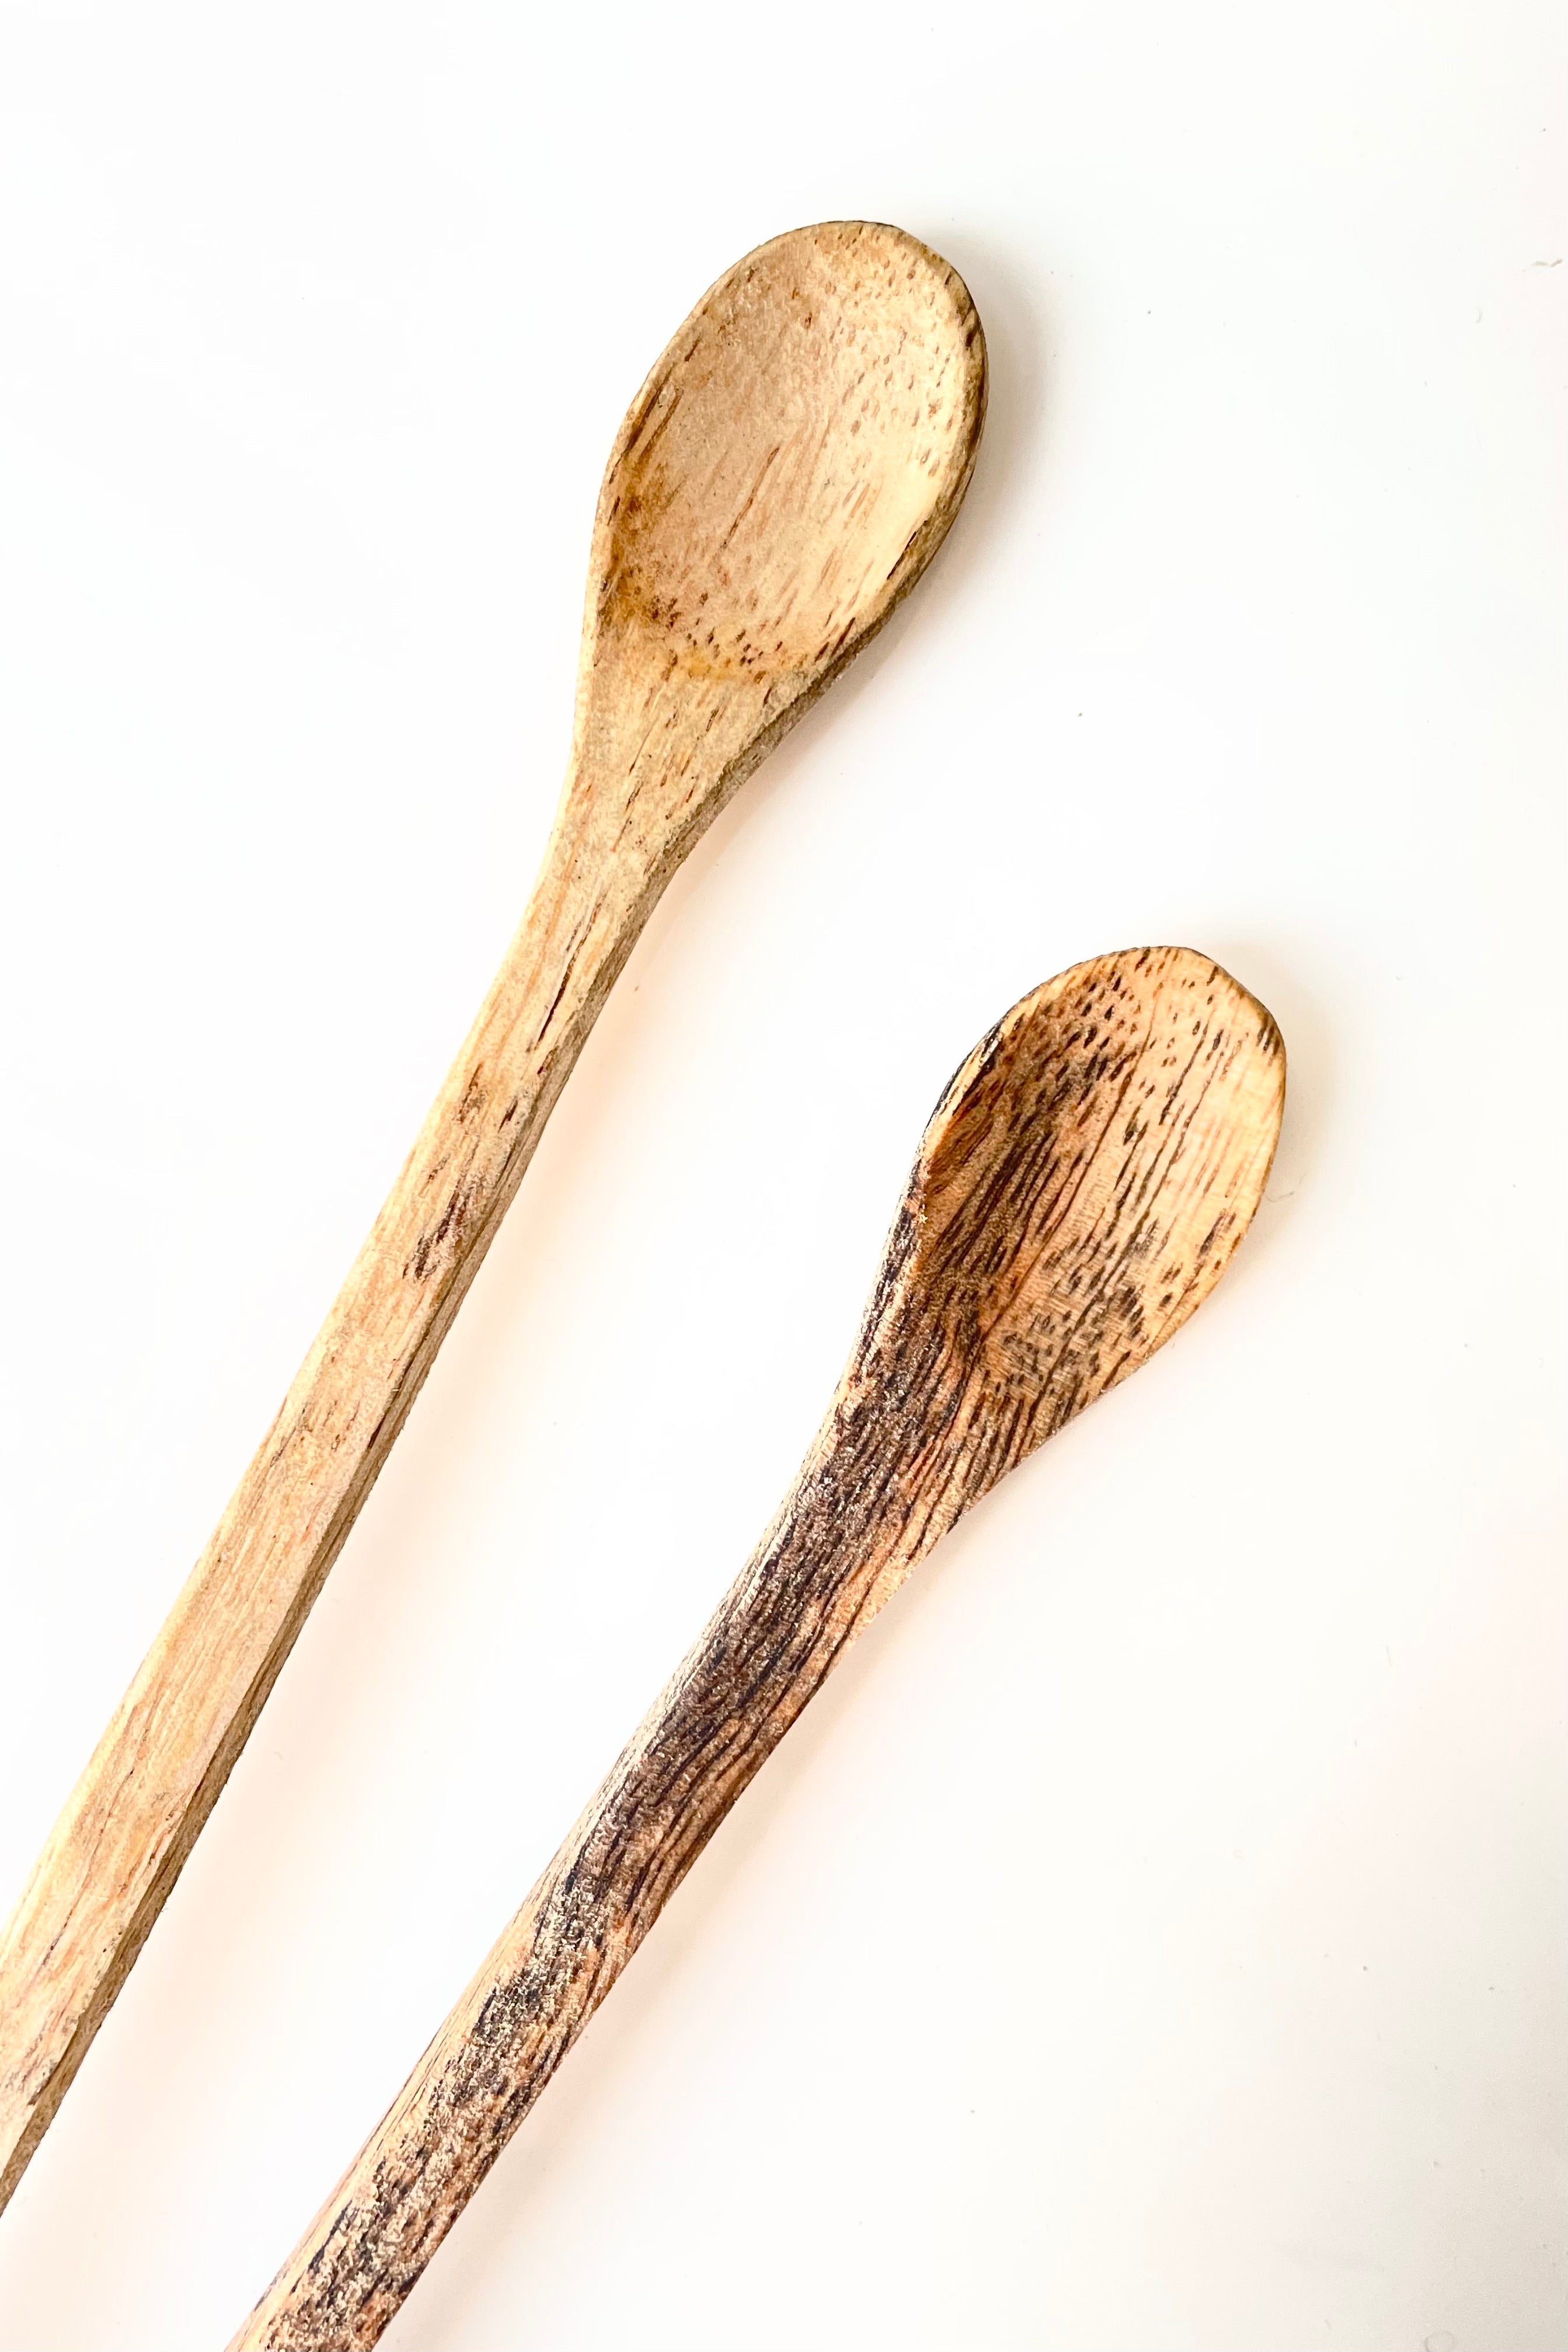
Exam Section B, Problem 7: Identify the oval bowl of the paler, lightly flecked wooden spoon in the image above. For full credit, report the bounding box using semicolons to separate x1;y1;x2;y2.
595;221;985;684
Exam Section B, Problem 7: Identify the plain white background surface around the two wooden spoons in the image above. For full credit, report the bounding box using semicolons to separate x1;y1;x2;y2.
0;0;1568;2352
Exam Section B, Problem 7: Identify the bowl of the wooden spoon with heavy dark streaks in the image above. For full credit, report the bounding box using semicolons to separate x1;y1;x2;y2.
856;948;1286;1503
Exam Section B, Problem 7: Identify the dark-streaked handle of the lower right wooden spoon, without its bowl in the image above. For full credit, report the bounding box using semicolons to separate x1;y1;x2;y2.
231;1373;957;2352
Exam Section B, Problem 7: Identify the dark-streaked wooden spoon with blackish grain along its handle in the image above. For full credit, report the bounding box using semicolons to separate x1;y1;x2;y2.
231;948;1286;2352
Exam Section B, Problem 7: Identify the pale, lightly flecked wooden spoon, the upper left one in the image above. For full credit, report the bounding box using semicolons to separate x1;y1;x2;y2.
0;221;985;2206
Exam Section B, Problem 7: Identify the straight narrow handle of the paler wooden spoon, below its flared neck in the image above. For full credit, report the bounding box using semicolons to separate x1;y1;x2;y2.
0;835;646;2206
